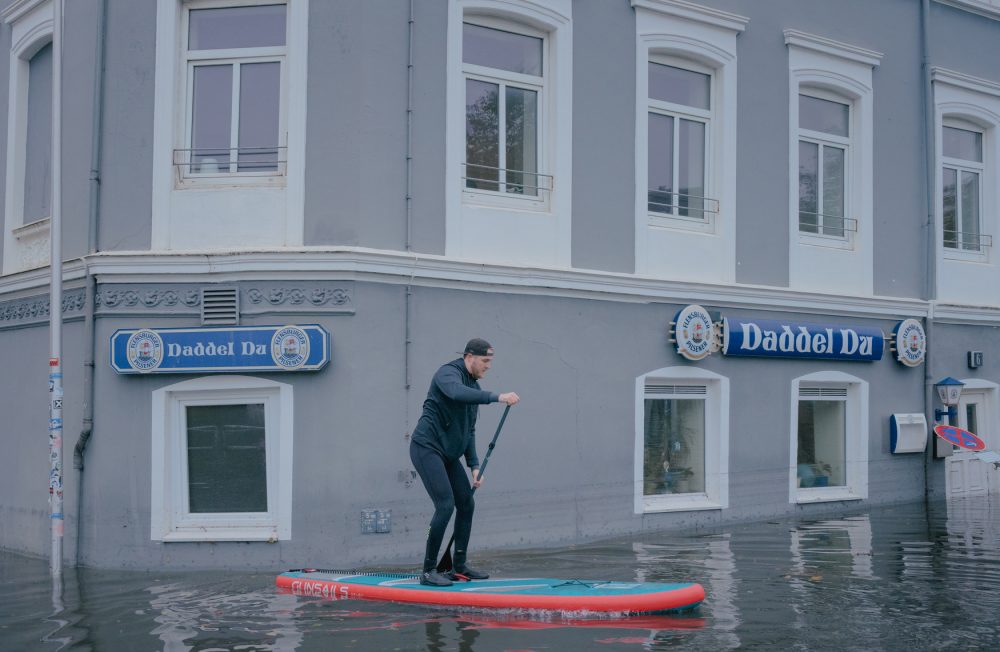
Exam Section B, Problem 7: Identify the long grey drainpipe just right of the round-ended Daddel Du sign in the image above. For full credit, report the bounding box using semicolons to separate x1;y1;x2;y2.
920;0;937;503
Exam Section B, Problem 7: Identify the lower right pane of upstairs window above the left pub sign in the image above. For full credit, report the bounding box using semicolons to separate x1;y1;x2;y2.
239;62;281;172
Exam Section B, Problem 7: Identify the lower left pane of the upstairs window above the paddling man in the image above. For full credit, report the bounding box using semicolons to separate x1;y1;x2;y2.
465;79;500;190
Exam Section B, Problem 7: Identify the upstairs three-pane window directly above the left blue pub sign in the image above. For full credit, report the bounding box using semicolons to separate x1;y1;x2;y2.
178;4;287;176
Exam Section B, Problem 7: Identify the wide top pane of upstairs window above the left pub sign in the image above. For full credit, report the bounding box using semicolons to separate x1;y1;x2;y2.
188;5;285;50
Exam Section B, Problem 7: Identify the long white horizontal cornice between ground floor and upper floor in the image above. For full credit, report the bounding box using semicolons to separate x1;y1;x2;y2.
0;247;928;319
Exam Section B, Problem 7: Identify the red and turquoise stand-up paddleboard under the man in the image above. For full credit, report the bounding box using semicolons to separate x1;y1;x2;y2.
277;569;705;614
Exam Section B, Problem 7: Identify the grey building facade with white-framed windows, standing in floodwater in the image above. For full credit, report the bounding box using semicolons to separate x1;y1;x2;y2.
0;0;1000;569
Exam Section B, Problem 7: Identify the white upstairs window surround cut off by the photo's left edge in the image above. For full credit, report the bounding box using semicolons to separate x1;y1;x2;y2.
0;0;54;274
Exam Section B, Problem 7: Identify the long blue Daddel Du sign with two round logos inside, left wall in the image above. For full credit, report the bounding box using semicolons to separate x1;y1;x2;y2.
111;324;330;374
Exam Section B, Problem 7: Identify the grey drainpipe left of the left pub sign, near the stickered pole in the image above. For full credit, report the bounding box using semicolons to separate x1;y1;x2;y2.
73;0;108;566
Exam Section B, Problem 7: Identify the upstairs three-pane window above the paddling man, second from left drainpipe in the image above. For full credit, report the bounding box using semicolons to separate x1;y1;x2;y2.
462;23;551;197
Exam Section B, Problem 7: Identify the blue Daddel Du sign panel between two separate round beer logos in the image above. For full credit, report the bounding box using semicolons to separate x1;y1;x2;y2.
722;318;885;362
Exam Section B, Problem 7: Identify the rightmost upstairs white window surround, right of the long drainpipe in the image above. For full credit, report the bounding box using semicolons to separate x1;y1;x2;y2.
931;67;1000;306
